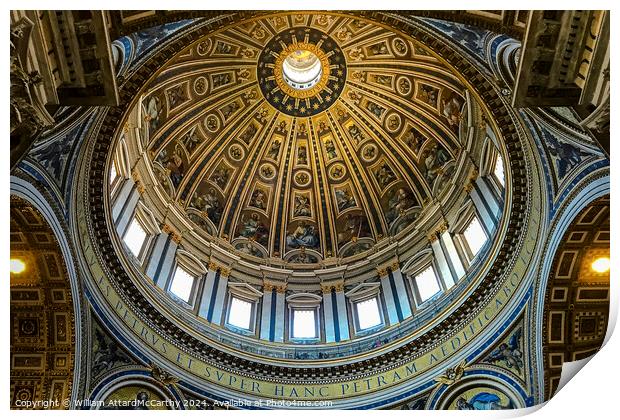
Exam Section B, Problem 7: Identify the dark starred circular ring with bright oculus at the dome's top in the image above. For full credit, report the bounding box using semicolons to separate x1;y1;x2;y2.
258;28;347;117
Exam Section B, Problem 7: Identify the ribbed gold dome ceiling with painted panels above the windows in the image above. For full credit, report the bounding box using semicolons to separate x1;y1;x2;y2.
142;14;465;263
